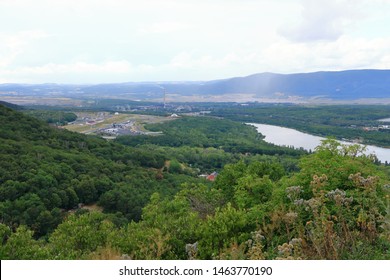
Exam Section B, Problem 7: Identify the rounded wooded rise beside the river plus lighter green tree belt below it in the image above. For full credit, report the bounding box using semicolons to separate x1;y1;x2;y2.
116;117;307;172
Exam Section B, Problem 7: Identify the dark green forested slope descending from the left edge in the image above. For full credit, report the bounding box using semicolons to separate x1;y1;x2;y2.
0;105;200;236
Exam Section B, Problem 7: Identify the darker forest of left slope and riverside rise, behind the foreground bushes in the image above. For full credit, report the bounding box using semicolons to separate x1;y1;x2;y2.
0;105;296;240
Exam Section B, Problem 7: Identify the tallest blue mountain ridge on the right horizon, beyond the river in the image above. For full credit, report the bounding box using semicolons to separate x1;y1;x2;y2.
203;70;390;100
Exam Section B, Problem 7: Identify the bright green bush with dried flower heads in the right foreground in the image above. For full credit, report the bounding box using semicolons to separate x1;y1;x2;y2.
256;140;390;259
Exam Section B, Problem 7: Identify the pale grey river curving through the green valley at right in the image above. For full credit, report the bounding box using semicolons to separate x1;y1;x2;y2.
247;123;390;162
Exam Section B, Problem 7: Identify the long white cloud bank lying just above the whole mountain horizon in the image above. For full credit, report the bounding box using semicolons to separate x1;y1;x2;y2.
0;33;390;83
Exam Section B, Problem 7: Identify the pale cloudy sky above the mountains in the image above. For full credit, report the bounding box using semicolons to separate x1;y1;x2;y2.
0;0;390;84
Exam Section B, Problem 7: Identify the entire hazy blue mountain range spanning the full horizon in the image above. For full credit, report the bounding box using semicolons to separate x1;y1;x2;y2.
0;70;390;100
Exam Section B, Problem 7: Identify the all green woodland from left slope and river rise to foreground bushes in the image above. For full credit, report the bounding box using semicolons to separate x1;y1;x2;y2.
0;105;390;259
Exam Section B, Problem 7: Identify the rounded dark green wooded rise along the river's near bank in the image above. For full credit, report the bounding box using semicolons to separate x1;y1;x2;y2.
117;117;303;156
